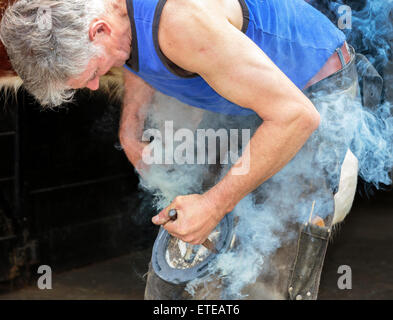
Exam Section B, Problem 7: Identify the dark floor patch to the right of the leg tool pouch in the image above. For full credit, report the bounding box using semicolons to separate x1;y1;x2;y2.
319;193;393;300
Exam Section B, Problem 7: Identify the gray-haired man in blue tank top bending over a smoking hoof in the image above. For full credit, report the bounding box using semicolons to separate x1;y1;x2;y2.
0;0;362;298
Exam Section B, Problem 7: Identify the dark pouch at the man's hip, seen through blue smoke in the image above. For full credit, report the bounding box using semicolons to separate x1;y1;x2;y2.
356;53;383;109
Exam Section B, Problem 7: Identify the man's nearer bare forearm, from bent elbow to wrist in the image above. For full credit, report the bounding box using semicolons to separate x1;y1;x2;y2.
206;110;319;218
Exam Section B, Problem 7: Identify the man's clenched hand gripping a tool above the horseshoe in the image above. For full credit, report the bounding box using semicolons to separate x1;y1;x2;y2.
153;194;226;245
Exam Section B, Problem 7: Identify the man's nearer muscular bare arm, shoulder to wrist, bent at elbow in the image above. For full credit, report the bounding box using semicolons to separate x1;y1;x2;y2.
159;0;319;218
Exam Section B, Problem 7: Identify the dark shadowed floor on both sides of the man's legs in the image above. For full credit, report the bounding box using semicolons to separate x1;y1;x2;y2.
0;194;393;300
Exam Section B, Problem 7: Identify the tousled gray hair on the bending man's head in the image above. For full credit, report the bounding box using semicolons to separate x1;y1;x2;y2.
0;0;106;107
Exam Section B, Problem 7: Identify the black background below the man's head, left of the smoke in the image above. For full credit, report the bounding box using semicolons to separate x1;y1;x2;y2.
0;90;159;290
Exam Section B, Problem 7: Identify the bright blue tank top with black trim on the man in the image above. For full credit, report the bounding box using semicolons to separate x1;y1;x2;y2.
125;0;345;115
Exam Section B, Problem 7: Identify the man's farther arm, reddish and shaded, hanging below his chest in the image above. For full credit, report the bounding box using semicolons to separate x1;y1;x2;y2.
119;69;154;169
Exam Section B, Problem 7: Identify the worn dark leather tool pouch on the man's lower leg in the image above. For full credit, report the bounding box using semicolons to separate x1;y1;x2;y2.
288;223;330;300
